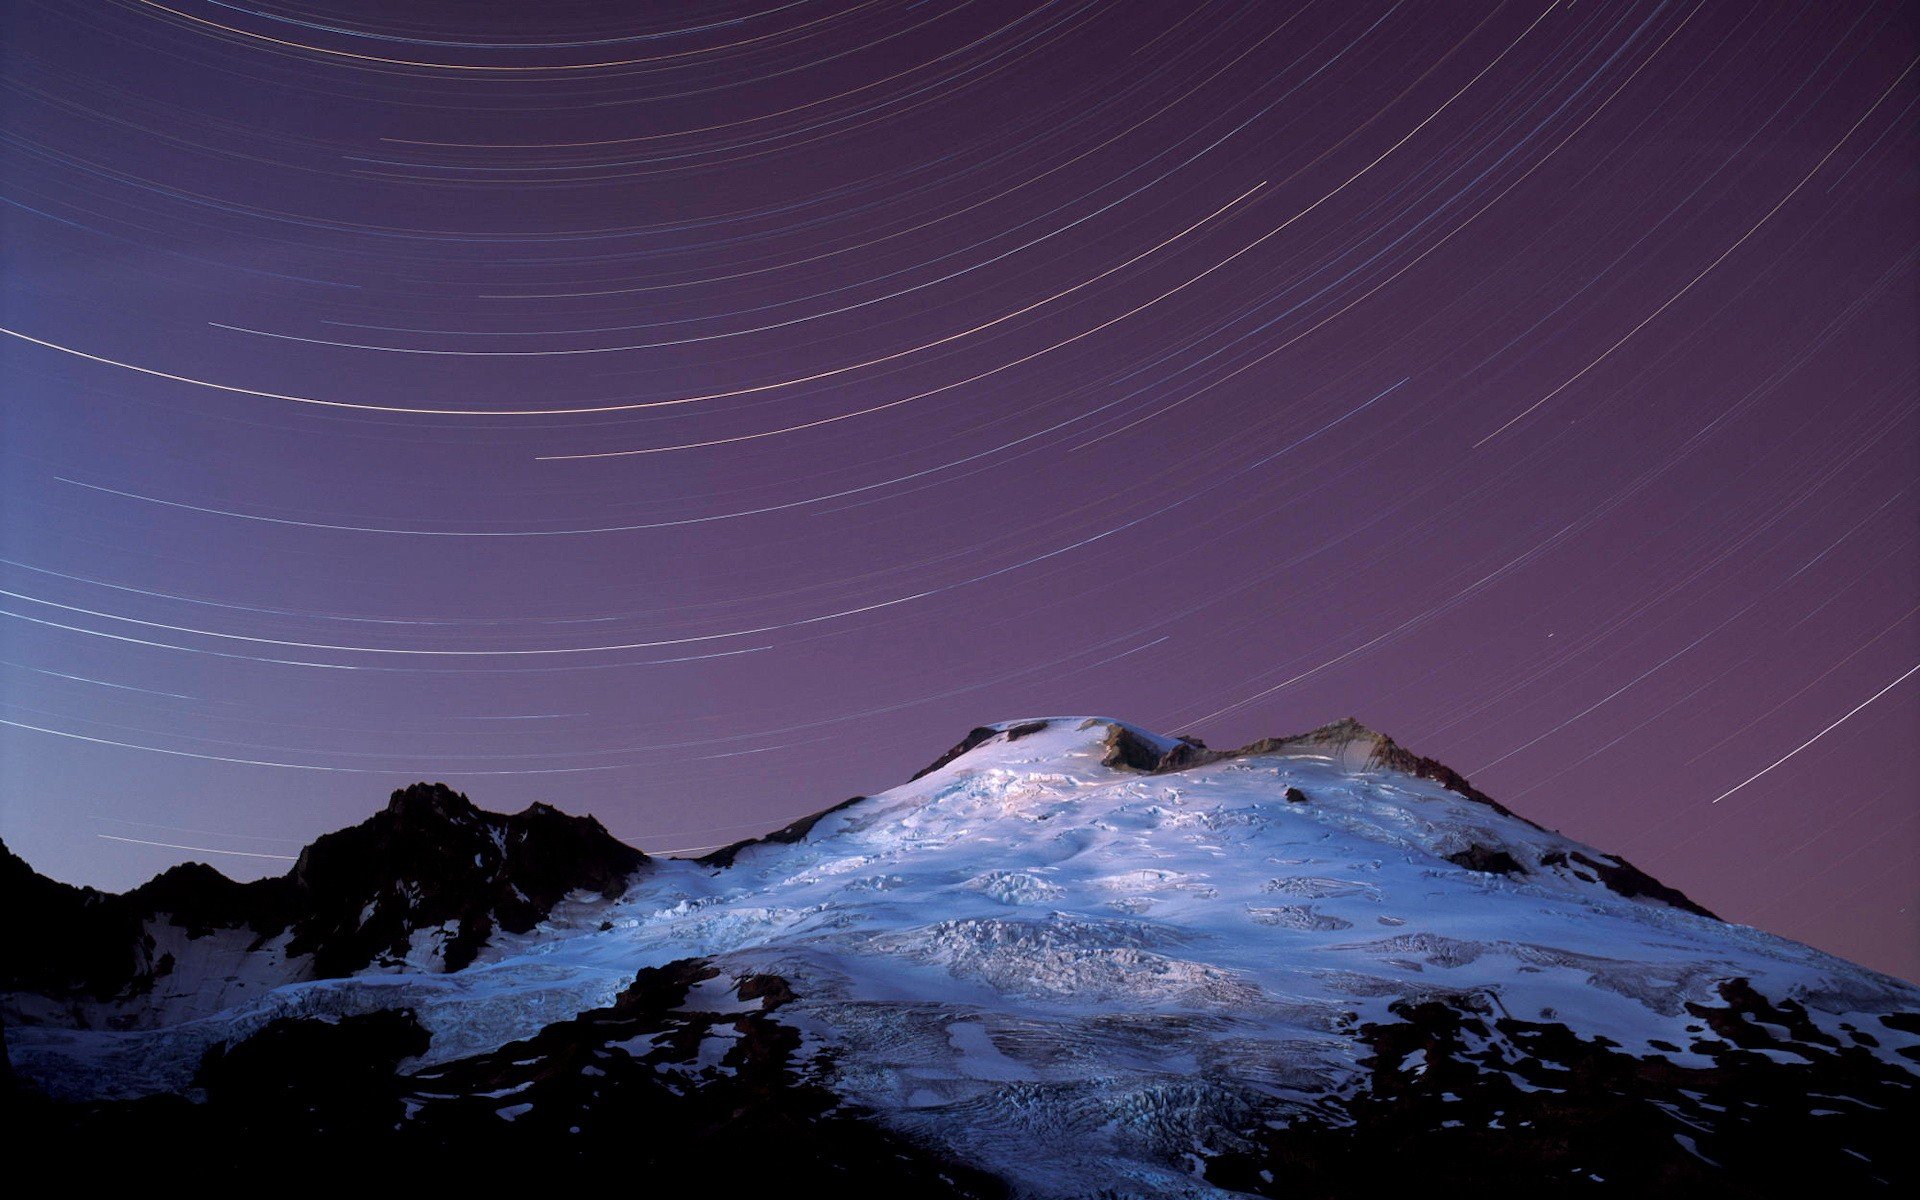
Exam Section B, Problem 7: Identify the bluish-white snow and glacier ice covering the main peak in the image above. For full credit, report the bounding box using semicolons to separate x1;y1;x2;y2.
8;718;1920;1194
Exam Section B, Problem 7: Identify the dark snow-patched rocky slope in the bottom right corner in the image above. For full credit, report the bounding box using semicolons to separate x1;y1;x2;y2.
1206;979;1920;1200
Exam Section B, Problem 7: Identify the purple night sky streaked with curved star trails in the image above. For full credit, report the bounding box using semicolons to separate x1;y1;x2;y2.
0;0;1920;979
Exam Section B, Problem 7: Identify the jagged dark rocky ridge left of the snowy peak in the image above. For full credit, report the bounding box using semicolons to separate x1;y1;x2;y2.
0;783;647;1027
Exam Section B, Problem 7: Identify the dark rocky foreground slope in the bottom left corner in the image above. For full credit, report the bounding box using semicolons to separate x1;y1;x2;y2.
0;958;1006;1200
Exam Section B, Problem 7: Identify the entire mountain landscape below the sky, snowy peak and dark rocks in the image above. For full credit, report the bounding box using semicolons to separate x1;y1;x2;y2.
0;718;1920;1196
